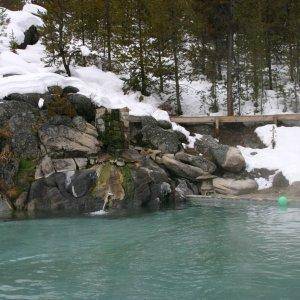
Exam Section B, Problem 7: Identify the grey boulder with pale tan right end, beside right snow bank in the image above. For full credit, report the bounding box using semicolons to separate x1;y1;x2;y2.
195;135;246;173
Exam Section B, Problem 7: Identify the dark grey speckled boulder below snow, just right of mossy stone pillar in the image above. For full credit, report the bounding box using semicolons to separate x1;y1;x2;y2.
141;117;182;153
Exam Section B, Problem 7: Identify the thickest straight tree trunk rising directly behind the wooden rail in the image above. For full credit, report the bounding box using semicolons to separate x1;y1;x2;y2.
227;0;234;116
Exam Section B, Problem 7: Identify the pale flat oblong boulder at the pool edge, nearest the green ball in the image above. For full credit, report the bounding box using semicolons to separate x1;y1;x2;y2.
213;178;258;195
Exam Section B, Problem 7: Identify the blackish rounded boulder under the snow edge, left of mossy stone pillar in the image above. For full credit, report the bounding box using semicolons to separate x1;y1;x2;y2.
67;94;96;122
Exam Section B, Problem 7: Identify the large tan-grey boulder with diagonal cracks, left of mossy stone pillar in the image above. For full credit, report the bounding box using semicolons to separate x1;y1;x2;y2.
38;124;100;157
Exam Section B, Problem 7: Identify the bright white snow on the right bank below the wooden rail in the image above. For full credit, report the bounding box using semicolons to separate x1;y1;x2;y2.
239;125;300;188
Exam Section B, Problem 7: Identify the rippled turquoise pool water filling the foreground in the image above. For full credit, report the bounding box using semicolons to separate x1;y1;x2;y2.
0;203;300;300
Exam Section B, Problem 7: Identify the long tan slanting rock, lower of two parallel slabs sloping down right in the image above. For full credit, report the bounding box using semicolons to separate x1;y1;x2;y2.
161;155;207;181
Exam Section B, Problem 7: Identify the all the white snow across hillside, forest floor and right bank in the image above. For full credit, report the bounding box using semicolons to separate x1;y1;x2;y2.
0;4;300;188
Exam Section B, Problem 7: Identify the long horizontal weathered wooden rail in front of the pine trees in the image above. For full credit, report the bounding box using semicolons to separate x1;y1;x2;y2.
171;114;300;125
